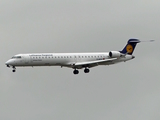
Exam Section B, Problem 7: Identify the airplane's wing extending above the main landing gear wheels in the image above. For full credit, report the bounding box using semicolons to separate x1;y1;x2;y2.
68;58;117;69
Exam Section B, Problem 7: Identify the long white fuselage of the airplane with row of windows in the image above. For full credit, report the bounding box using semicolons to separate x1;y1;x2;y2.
6;52;134;69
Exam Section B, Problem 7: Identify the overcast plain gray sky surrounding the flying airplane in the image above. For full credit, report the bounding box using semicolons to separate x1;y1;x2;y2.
0;0;160;120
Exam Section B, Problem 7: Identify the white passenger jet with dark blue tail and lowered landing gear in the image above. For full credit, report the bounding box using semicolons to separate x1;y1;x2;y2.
5;39;153;75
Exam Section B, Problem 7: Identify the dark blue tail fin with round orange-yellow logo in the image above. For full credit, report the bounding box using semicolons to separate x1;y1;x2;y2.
120;39;140;55
